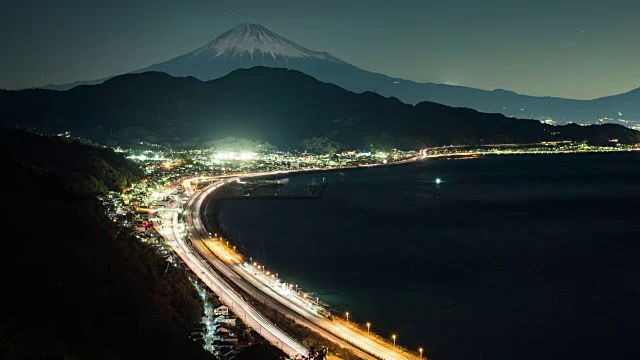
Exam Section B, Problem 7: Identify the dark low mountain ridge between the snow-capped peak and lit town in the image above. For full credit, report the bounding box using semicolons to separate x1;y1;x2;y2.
0;67;640;149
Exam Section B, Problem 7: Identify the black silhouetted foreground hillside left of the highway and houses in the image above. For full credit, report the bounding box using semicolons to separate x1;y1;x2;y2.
0;130;211;360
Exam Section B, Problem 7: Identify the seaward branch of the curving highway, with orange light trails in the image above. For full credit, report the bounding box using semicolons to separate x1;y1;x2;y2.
189;156;425;359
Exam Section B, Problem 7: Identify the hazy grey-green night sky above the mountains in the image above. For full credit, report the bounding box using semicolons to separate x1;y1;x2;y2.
0;0;640;98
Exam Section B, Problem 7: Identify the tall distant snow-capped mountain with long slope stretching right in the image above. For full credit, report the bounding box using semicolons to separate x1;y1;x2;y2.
42;24;640;126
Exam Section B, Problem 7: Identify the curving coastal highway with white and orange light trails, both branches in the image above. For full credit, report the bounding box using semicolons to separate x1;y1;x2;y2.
159;151;426;360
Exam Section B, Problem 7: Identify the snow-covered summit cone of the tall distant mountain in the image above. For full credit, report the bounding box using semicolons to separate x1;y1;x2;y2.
192;23;343;63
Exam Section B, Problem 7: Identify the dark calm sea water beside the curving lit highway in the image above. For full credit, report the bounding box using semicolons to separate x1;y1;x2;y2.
212;153;640;360
